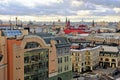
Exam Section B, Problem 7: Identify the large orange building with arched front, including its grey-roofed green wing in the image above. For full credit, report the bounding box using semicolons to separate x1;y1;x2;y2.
0;30;72;80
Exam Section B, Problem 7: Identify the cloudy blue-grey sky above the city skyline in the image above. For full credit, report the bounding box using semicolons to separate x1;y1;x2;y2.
0;0;120;22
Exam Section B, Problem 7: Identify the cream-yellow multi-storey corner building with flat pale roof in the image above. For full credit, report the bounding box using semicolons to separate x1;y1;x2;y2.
71;46;101;72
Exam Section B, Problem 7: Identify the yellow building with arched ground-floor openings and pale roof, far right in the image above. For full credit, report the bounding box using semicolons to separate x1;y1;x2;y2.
99;46;120;68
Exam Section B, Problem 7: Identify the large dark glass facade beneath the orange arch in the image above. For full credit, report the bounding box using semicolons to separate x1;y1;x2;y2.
24;49;48;80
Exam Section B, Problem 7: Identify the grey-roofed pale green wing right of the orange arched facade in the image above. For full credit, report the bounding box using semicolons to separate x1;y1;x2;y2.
43;36;72;80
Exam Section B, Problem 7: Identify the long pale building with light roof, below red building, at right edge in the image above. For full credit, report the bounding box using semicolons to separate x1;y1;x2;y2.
86;33;120;44
